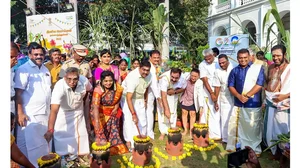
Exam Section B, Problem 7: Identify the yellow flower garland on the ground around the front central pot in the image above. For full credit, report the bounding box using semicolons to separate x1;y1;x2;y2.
117;155;161;168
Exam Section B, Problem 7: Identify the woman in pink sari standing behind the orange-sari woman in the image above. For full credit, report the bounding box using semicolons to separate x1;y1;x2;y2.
94;49;121;83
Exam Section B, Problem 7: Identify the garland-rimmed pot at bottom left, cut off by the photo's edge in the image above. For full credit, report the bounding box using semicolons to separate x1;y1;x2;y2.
37;153;61;168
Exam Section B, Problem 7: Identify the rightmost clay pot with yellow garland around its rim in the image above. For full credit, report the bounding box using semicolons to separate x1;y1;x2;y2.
192;124;209;147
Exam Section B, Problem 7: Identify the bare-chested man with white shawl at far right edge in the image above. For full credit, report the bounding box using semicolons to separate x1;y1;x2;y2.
264;45;290;158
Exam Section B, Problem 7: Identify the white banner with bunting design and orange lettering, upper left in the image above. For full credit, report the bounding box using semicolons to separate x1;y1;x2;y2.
26;12;78;53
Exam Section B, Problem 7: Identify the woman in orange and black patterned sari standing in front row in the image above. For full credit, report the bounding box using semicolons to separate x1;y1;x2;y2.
91;71;128;155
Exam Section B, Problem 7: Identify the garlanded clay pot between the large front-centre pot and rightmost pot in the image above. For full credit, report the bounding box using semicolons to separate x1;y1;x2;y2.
166;127;183;156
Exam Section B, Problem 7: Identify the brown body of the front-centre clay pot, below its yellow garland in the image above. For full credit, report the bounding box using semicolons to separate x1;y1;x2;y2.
132;142;153;166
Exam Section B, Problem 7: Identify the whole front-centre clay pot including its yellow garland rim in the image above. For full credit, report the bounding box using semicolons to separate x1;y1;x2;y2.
132;136;153;166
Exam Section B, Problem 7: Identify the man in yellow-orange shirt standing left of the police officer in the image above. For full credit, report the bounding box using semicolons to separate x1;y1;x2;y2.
45;48;61;89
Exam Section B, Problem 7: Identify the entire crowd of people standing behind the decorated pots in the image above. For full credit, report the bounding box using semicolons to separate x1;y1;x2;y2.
11;43;290;167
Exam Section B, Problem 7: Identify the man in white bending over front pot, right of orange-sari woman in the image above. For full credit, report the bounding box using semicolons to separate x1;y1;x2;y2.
122;61;151;151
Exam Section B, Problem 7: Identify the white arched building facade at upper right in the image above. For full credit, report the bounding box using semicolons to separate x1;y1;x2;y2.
207;0;290;46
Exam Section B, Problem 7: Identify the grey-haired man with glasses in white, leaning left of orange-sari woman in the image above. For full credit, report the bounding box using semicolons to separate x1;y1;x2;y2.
45;67;92;156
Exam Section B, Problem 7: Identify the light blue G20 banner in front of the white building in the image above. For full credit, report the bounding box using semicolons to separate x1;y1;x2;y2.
209;34;249;66
